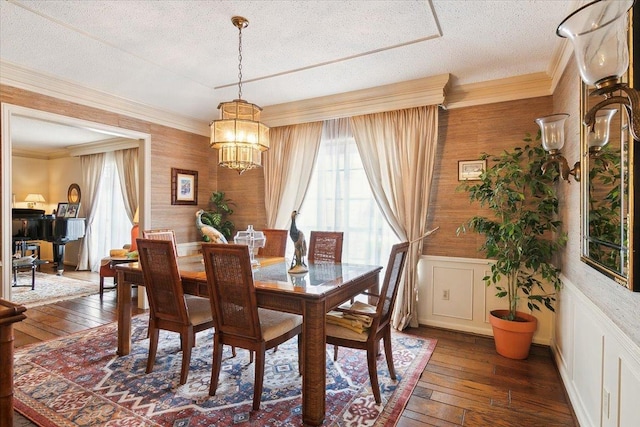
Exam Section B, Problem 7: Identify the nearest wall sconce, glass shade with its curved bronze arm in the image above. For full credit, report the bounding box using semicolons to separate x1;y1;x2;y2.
556;0;640;141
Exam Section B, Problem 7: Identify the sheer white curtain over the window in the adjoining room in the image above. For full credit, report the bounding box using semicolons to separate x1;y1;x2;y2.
78;152;133;271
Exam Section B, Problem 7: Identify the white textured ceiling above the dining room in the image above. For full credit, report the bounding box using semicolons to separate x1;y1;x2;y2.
0;0;576;151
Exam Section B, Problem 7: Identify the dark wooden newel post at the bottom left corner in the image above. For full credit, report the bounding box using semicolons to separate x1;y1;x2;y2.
0;299;27;426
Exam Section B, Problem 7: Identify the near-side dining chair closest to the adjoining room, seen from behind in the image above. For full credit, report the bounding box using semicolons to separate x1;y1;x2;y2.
137;239;214;384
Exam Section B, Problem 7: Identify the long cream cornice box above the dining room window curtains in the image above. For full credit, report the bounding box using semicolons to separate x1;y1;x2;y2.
261;74;449;127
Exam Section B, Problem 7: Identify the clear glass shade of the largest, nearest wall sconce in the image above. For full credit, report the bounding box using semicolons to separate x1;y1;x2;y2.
556;0;634;86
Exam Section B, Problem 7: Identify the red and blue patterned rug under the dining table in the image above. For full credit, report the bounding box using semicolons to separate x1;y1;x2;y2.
14;315;436;427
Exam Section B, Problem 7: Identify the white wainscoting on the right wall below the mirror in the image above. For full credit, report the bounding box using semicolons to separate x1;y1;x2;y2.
551;277;640;427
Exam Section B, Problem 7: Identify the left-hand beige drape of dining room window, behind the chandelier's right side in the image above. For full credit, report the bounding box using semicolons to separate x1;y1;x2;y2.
263;122;322;229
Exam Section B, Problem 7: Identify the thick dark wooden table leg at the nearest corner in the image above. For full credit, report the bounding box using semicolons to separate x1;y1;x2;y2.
302;300;326;426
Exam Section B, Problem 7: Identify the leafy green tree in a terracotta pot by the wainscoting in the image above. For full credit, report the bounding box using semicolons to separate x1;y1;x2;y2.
458;132;566;359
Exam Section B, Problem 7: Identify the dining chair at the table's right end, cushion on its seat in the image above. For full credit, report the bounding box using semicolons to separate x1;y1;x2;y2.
326;242;409;404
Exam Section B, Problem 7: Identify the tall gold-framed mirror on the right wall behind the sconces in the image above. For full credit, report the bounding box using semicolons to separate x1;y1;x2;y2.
580;6;640;291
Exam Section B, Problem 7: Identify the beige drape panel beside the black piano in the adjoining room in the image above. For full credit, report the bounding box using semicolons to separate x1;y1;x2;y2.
78;153;105;270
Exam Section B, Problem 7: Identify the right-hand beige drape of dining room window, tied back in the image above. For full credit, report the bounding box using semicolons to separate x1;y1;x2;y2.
351;105;438;330
